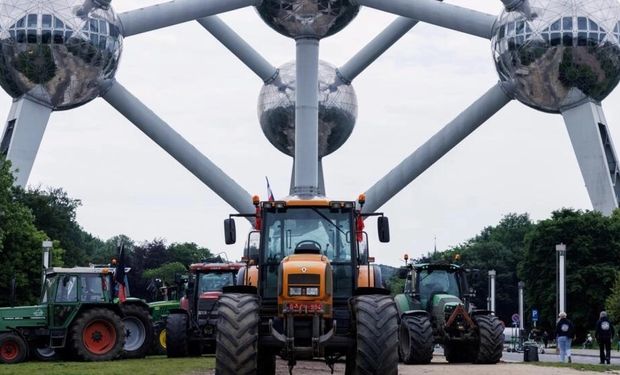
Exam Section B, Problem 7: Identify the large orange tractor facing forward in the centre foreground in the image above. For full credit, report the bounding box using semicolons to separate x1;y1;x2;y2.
216;196;398;375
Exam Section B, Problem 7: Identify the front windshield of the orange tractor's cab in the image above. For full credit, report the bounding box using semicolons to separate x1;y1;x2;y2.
262;207;352;264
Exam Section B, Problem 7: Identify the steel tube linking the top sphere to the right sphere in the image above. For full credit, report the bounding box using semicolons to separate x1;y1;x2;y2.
354;0;497;39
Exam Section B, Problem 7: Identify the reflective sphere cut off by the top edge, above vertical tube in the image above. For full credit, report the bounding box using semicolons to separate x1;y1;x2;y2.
256;0;359;38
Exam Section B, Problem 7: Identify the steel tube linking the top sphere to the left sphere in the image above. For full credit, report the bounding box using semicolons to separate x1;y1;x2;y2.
118;0;258;37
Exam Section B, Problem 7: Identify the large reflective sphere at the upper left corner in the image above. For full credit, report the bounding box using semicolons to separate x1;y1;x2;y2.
0;0;123;110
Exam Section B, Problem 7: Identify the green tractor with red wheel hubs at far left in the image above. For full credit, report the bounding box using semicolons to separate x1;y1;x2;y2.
0;267;152;363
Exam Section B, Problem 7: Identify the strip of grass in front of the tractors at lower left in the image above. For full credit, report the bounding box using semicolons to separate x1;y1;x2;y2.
0;356;215;375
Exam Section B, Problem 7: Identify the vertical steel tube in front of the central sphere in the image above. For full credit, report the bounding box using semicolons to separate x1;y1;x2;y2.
294;38;319;195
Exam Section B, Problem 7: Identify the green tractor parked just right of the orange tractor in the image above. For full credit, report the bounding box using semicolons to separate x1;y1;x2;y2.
394;263;504;364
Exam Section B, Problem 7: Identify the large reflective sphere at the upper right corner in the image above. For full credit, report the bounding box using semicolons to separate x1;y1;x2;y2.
492;0;620;113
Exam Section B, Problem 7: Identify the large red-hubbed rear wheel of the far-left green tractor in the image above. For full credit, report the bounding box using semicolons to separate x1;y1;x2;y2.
69;309;125;361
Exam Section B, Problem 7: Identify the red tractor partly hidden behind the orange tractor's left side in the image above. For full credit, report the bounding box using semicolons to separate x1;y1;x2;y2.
166;262;245;358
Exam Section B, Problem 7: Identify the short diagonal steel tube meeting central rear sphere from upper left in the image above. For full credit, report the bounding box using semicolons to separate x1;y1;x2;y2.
198;16;278;82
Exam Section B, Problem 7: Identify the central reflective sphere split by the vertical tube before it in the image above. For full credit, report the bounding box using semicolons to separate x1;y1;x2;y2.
258;61;357;157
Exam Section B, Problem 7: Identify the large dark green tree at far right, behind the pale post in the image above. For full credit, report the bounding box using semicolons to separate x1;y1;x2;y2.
519;209;620;340
